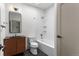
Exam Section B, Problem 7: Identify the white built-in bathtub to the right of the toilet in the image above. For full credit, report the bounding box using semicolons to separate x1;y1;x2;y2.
37;39;56;56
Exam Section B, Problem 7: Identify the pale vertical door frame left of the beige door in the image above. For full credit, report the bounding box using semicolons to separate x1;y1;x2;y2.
57;3;64;56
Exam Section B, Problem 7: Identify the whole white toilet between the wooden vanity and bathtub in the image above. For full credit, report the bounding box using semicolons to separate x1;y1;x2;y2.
29;37;38;55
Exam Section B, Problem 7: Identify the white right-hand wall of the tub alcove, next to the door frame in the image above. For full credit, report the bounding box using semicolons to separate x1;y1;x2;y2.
45;4;57;55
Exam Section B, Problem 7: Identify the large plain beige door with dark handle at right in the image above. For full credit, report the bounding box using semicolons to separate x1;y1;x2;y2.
60;3;79;56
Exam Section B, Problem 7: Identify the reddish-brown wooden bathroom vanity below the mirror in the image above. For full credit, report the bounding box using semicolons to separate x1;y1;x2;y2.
3;36;26;56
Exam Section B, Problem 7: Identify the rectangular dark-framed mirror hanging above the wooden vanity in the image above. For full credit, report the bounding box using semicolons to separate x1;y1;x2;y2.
9;11;21;33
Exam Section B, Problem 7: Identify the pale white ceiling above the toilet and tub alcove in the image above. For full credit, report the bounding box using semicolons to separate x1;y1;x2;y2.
24;3;54;10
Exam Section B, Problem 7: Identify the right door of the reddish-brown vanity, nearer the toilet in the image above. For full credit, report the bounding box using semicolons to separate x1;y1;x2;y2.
16;37;25;54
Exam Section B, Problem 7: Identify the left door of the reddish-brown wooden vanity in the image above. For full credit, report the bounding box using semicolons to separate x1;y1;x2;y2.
4;38;16;56
